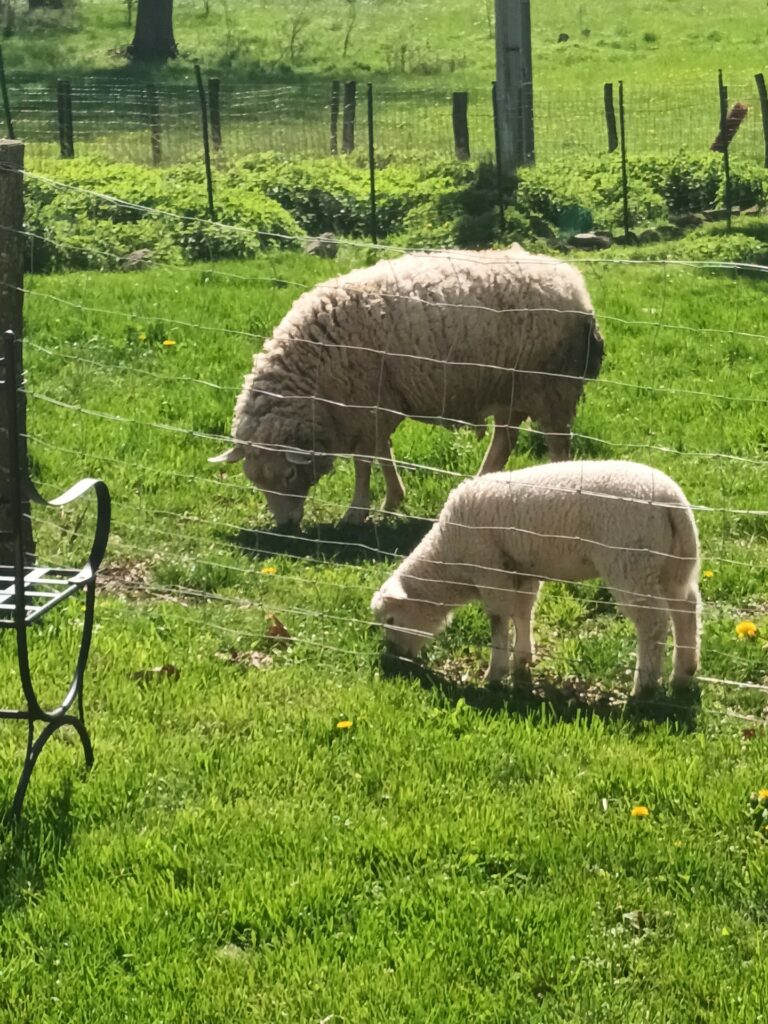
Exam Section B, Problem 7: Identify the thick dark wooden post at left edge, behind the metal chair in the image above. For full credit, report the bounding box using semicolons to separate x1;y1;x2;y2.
0;139;35;565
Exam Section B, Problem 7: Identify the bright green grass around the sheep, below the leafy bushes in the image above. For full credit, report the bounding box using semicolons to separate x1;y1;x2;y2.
0;243;768;1024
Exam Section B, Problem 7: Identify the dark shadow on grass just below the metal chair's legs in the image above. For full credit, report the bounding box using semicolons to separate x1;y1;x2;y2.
0;778;75;912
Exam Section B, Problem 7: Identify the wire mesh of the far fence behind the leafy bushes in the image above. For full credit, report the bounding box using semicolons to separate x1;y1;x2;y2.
4;75;768;164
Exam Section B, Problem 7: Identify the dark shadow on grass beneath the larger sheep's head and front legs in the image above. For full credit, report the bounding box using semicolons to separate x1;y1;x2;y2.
229;519;432;565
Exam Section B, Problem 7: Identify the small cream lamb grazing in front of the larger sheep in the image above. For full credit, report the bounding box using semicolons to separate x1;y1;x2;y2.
371;461;699;695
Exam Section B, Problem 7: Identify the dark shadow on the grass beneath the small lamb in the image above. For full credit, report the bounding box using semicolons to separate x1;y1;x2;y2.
381;653;700;732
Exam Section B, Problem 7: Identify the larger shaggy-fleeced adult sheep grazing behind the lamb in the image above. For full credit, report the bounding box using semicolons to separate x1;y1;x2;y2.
210;246;603;525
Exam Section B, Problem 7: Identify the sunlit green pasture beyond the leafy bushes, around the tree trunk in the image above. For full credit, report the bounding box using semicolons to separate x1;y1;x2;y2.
3;0;766;162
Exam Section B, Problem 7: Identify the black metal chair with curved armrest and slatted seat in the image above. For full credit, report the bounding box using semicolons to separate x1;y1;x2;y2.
0;331;111;820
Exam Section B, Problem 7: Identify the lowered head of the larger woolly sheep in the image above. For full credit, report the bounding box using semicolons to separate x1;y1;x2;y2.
208;444;333;529
